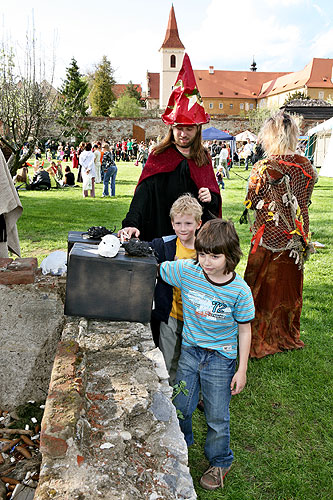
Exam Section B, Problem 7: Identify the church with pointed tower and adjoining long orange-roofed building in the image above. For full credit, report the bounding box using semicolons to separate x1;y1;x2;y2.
146;6;333;116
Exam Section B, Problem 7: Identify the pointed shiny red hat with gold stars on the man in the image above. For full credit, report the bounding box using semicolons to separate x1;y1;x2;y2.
162;54;210;125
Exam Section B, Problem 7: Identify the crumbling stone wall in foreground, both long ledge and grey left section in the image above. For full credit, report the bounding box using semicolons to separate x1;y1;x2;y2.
0;280;197;500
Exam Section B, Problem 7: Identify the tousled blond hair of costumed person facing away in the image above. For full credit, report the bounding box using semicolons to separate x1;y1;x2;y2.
258;111;299;155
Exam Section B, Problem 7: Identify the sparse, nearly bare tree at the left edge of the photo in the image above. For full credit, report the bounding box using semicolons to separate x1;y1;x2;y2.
0;35;57;176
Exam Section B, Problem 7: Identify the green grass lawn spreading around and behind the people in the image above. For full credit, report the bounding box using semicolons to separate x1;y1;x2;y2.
18;158;333;500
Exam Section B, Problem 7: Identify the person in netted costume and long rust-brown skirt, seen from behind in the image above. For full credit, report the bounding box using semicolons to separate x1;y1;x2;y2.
244;111;317;358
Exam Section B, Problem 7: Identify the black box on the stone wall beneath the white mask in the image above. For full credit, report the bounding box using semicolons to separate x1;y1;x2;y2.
65;243;157;323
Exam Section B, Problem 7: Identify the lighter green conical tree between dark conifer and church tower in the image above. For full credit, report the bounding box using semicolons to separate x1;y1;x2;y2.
89;56;116;116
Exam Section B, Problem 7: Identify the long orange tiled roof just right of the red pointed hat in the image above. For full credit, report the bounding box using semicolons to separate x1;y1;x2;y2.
194;69;286;99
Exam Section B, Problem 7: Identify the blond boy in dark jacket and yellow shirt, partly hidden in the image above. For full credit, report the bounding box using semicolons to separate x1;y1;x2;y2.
151;194;202;385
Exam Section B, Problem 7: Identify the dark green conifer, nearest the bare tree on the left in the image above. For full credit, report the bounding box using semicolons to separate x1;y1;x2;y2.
58;57;88;140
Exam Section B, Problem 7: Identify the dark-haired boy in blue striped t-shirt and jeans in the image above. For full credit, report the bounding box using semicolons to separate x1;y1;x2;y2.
160;219;254;490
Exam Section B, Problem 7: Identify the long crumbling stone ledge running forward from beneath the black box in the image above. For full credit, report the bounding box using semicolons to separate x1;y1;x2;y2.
34;318;196;500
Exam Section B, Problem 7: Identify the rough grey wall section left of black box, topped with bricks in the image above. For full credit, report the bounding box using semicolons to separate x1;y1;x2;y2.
0;274;64;410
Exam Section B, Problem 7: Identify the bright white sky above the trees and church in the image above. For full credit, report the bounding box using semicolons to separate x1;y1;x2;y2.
0;0;333;89
